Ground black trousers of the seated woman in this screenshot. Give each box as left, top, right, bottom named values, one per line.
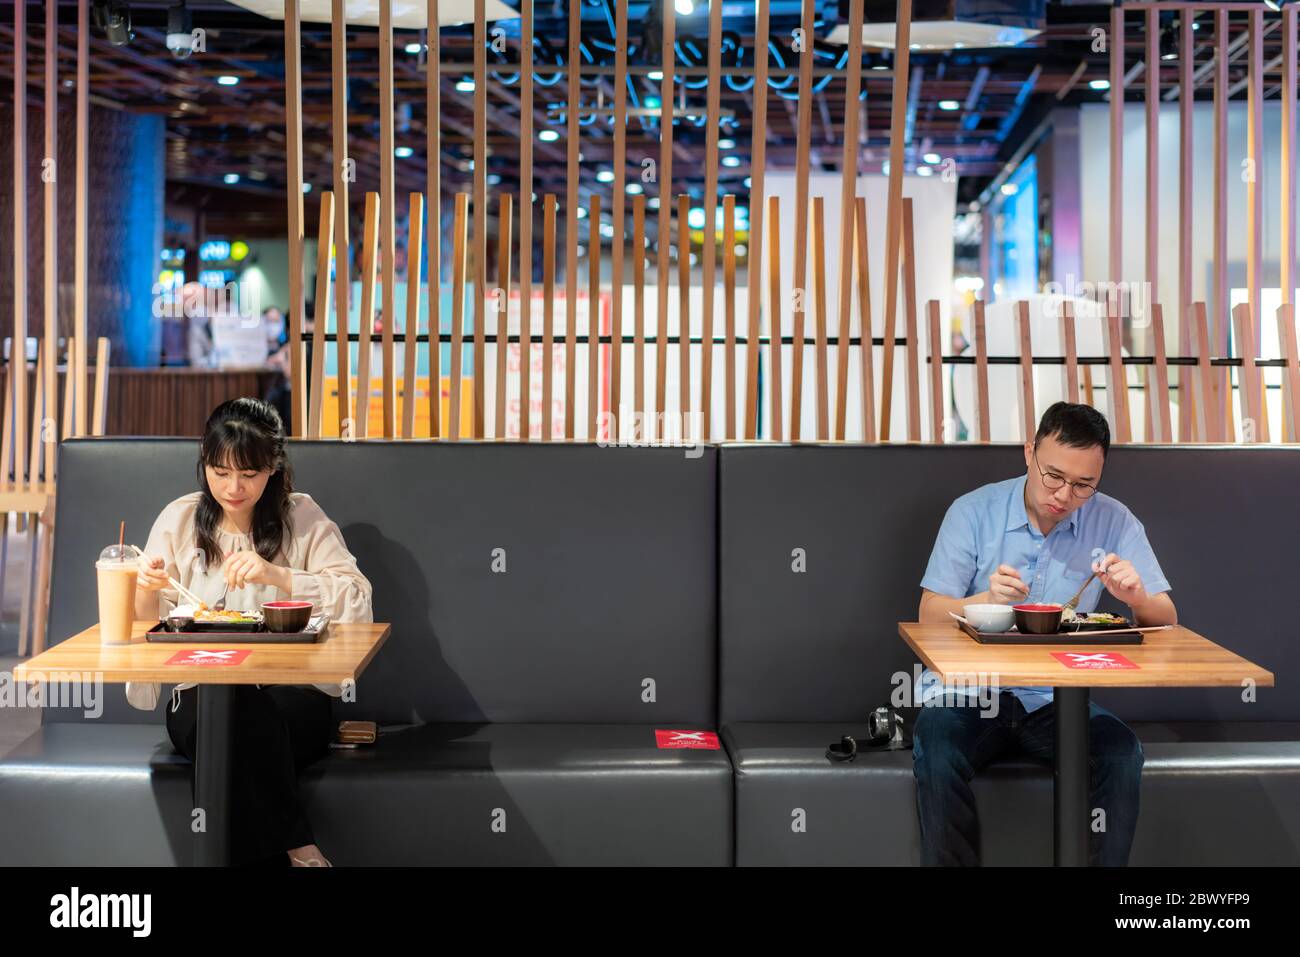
left=166, top=685, right=333, bottom=865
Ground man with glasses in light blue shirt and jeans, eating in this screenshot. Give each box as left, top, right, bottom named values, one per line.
left=913, top=402, right=1178, bottom=866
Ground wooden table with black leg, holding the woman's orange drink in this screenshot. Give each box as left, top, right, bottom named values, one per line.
left=13, top=622, right=393, bottom=865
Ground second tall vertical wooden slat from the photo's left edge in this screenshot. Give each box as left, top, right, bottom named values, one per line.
left=43, top=3, right=59, bottom=481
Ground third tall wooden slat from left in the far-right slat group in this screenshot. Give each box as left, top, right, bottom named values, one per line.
left=1170, top=9, right=1196, bottom=442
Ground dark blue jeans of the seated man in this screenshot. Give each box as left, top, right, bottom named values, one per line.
left=911, top=690, right=1143, bottom=867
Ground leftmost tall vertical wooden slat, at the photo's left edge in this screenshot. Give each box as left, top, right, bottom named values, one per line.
left=12, top=1, right=27, bottom=481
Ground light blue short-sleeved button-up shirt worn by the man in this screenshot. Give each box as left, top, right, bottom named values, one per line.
left=917, top=476, right=1169, bottom=711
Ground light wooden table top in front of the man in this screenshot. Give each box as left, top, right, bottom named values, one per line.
left=898, top=622, right=1273, bottom=688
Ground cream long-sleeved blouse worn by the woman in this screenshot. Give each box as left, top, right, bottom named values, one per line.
left=126, top=492, right=374, bottom=711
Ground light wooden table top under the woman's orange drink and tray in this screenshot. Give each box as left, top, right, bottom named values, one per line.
left=13, top=622, right=393, bottom=684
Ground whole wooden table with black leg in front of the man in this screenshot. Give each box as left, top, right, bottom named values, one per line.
left=898, top=622, right=1273, bottom=866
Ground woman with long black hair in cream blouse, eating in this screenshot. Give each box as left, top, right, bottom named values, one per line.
left=126, top=399, right=374, bottom=866
